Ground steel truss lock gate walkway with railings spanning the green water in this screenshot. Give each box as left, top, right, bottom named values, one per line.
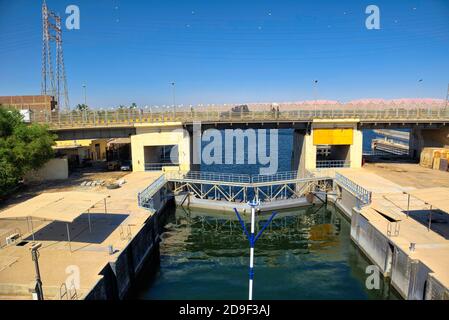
left=138, top=171, right=371, bottom=210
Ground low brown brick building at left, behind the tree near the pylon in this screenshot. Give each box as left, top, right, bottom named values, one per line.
left=0, top=95, right=57, bottom=112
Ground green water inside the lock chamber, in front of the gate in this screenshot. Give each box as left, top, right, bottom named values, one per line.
left=138, top=206, right=397, bottom=299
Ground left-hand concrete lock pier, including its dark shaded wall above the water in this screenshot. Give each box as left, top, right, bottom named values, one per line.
left=0, top=172, right=168, bottom=300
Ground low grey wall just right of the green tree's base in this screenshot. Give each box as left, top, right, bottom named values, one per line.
left=25, top=158, right=69, bottom=182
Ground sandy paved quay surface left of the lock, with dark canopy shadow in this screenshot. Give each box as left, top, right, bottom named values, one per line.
left=0, top=173, right=160, bottom=299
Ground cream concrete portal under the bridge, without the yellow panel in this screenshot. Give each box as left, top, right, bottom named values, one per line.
left=131, top=123, right=190, bottom=171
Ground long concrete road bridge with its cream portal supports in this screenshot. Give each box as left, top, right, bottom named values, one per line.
left=32, top=103, right=449, bottom=171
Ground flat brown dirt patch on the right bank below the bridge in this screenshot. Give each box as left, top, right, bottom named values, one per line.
left=363, top=162, right=449, bottom=189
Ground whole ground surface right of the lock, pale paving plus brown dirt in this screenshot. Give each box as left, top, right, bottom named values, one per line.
left=340, top=164, right=449, bottom=287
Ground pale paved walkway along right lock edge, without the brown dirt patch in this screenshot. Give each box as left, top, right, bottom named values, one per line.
left=339, top=165, right=449, bottom=288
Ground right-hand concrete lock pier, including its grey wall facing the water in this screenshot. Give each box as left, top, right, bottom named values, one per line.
left=330, top=169, right=449, bottom=300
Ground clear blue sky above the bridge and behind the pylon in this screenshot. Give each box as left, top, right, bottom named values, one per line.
left=0, top=0, right=449, bottom=107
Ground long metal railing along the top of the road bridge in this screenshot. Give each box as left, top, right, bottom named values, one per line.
left=26, top=104, right=449, bottom=129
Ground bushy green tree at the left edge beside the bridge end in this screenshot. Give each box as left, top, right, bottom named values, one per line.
left=0, top=108, right=56, bottom=196
